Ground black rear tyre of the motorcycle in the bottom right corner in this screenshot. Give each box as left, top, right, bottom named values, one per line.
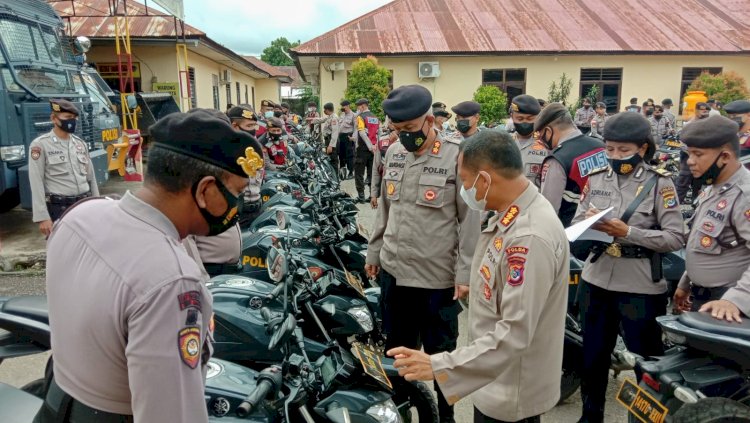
left=672, top=397, right=750, bottom=423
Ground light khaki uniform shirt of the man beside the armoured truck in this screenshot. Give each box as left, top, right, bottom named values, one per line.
left=29, top=131, right=99, bottom=222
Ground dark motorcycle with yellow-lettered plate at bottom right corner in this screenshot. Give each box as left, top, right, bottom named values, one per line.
left=617, top=312, right=750, bottom=423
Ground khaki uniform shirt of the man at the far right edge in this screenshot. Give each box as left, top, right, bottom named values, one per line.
left=678, top=167, right=750, bottom=316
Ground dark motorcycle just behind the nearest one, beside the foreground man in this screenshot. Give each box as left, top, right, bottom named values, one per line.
left=207, top=212, right=437, bottom=422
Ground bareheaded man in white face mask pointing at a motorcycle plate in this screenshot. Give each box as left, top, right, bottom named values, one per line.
left=388, top=131, right=569, bottom=422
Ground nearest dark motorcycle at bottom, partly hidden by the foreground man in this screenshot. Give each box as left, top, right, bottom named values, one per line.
left=0, top=294, right=402, bottom=423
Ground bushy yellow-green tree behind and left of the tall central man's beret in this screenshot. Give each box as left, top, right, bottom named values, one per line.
left=344, top=56, right=391, bottom=121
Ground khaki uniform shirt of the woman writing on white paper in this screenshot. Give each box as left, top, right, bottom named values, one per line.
left=573, top=163, right=685, bottom=294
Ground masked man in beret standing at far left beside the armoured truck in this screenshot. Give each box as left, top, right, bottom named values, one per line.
left=29, top=100, right=99, bottom=236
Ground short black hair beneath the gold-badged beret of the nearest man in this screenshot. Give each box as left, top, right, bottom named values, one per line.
left=144, top=144, right=228, bottom=194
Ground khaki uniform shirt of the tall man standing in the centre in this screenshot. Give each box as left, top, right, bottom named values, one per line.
left=367, top=137, right=479, bottom=289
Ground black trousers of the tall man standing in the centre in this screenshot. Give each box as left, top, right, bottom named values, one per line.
left=380, top=270, right=460, bottom=422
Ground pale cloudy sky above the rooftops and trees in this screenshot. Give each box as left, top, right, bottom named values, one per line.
left=151, top=0, right=392, bottom=56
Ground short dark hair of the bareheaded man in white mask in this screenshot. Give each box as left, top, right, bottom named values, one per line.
left=460, top=131, right=523, bottom=179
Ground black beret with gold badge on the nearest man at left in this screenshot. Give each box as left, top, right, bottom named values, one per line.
left=149, top=110, right=263, bottom=177
